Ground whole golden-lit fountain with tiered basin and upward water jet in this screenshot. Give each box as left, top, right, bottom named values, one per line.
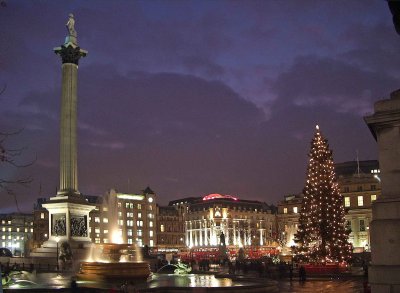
left=78, top=192, right=150, bottom=280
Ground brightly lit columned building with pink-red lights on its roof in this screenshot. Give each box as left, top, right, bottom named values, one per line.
left=172, top=194, right=276, bottom=251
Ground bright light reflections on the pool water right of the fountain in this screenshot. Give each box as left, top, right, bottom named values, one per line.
left=148, top=274, right=250, bottom=288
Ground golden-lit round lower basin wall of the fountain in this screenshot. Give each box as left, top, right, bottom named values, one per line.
left=77, top=262, right=150, bottom=281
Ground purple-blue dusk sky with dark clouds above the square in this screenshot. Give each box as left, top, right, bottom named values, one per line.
left=0, top=0, right=400, bottom=212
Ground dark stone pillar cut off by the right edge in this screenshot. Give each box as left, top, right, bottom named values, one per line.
left=364, top=90, right=400, bottom=293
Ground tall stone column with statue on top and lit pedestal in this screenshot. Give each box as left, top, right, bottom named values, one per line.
left=43, top=14, right=95, bottom=247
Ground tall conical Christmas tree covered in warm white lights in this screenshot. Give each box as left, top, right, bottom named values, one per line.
left=295, top=125, right=351, bottom=263
